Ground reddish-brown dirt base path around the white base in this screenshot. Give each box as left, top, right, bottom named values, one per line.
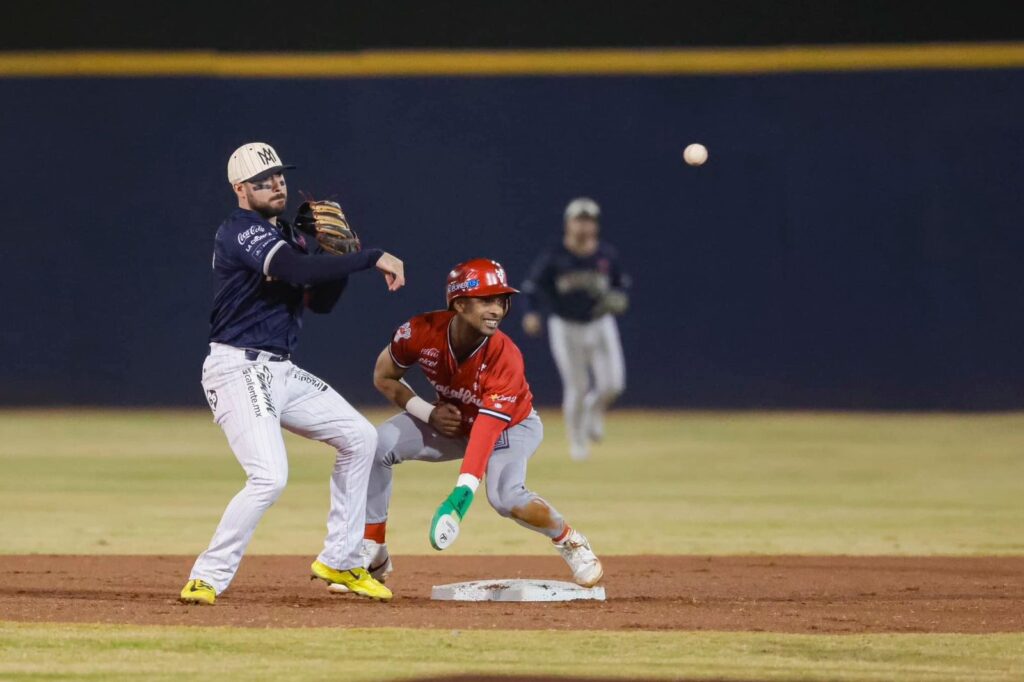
left=0, top=556, right=1024, bottom=633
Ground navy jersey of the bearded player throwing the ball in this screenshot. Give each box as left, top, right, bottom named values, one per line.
left=210, top=208, right=315, bottom=353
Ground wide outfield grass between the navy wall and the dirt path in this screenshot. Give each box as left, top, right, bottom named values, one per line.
left=0, top=411, right=1024, bottom=555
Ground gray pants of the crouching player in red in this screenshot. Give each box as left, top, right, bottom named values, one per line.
left=367, top=412, right=564, bottom=538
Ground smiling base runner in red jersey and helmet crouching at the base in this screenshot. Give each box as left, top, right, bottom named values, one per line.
left=362, top=258, right=604, bottom=587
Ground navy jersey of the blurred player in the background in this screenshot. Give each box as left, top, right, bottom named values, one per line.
left=521, top=242, right=630, bottom=322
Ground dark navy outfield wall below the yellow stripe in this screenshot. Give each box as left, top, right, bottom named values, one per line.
left=0, top=70, right=1024, bottom=409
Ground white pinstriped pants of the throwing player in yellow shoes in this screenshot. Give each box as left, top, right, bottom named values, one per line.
left=189, top=343, right=377, bottom=594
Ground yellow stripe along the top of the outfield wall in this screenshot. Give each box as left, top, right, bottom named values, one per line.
left=6, top=43, right=1024, bottom=78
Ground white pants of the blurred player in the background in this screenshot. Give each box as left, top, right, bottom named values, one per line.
left=548, top=314, right=626, bottom=459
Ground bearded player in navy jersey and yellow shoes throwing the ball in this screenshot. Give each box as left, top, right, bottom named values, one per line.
left=181, top=142, right=404, bottom=604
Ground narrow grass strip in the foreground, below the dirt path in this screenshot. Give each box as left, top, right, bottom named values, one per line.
left=0, top=623, right=1024, bottom=682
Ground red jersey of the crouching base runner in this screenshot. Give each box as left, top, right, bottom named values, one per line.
left=389, top=310, right=534, bottom=433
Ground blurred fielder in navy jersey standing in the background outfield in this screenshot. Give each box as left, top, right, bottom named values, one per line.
left=522, top=197, right=630, bottom=460
